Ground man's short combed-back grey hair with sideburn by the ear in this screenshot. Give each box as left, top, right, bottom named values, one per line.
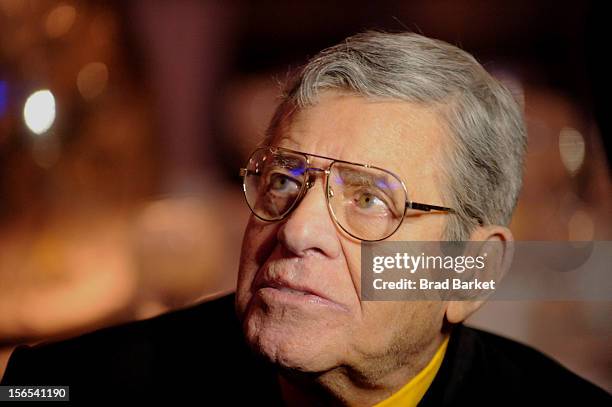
left=268, top=31, right=527, bottom=240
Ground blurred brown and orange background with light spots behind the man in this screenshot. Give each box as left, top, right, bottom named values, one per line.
left=0, top=0, right=612, bottom=391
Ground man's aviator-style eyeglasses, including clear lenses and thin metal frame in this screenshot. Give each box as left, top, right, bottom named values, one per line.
left=240, top=146, right=455, bottom=242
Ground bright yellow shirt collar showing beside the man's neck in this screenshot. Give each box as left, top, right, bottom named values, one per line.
left=374, top=336, right=448, bottom=407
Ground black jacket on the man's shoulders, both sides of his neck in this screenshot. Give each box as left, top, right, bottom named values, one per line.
left=1, top=295, right=612, bottom=406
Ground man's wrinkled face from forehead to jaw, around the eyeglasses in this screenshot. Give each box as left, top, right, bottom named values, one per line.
left=236, top=92, right=448, bottom=380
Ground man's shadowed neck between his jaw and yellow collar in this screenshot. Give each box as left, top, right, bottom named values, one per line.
left=278, top=336, right=445, bottom=407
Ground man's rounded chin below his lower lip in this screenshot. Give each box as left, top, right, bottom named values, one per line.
left=243, top=302, right=342, bottom=372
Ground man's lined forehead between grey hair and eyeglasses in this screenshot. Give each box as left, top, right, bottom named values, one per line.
left=269, top=92, right=447, bottom=182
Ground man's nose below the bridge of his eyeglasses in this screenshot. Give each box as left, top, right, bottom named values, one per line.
left=278, top=174, right=341, bottom=258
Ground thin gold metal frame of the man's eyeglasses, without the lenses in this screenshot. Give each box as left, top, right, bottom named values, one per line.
left=240, top=146, right=456, bottom=242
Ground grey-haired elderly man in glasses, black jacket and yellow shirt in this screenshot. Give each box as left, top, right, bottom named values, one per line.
left=4, top=32, right=610, bottom=406
